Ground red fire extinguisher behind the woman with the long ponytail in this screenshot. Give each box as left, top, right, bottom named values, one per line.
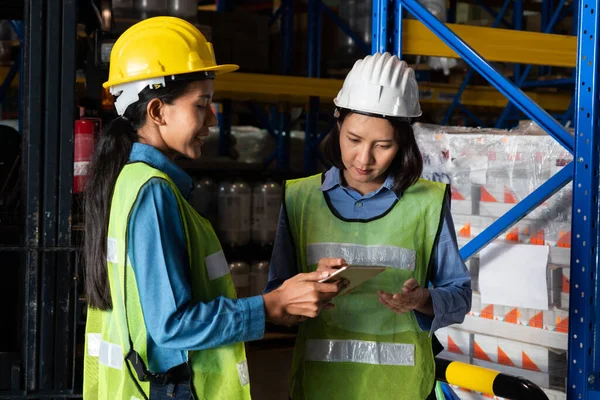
left=73, top=118, right=102, bottom=193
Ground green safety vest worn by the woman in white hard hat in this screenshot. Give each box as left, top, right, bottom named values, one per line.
left=285, top=175, right=447, bottom=400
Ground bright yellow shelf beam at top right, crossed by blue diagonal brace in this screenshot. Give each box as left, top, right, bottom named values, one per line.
left=402, top=19, right=577, bottom=68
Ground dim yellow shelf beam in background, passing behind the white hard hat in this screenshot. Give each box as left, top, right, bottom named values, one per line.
left=215, top=72, right=571, bottom=111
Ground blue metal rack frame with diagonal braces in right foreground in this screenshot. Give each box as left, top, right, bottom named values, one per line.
left=372, top=0, right=600, bottom=400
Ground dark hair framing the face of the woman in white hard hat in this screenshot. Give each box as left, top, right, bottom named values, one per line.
left=323, top=109, right=423, bottom=193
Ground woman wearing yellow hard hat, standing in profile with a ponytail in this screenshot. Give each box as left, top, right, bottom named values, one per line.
left=83, top=17, right=340, bottom=400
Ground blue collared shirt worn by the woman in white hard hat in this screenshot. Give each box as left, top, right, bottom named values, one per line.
left=265, top=167, right=471, bottom=332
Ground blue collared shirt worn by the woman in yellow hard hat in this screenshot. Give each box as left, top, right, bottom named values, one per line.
left=127, top=143, right=265, bottom=372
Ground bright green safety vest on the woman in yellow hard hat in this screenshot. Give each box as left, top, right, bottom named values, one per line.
left=83, top=162, right=250, bottom=400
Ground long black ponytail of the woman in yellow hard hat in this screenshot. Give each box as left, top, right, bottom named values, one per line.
left=83, top=80, right=192, bottom=310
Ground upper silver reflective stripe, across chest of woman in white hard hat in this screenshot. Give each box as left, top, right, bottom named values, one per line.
left=306, top=243, right=416, bottom=271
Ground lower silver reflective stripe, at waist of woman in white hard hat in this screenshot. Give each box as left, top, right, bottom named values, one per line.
left=304, top=339, right=415, bottom=367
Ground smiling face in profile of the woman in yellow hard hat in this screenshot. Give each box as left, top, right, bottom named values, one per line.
left=160, top=79, right=217, bottom=159
